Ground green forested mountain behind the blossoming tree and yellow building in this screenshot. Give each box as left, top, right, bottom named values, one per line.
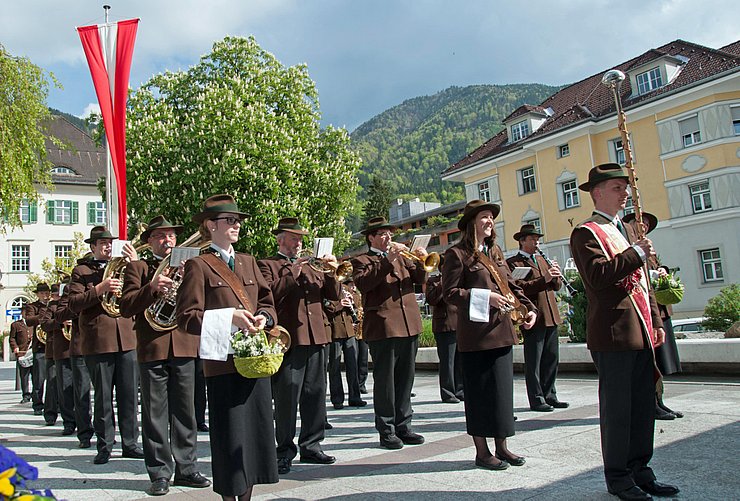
left=350, top=84, right=560, bottom=203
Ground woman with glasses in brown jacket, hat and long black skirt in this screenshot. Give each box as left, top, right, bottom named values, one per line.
left=177, top=195, right=278, bottom=500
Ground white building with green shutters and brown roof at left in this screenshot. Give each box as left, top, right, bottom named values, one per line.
left=0, top=117, right=106, bottom=331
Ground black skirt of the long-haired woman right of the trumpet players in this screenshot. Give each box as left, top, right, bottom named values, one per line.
left=460, top=346, right=514, bottom=438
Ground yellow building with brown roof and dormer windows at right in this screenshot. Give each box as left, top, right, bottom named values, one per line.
left=442, top=40, right=740, bottom=317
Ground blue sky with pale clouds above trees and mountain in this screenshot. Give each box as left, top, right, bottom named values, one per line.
left=0, top=0, right=740, bottom=132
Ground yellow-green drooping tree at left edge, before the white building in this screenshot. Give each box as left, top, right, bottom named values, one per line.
left=0, top=45, right=59, bottom=233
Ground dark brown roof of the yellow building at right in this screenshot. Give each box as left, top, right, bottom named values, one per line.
left=442, top=40, right=740, bottom=175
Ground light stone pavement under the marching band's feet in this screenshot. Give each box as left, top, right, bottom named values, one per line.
left=0, top=363, right=740, bottom=501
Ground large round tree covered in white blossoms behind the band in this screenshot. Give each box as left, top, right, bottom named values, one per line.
left=127, top=37, right=360, bottom=256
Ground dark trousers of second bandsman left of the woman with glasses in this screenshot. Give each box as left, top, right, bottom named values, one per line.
left=85, top=350, right=139, bottom=452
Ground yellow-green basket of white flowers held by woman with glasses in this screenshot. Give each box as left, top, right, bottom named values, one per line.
left=231, top=327, right=290, bottom=379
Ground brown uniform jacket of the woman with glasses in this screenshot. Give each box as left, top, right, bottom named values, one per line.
left=177, top=253, right=277, bottom=377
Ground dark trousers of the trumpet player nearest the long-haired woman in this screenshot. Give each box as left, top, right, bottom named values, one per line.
left=368, top=336, right=419, bottom=436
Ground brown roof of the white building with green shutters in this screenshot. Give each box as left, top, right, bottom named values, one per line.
left=46, top=115, right=106, bottom=185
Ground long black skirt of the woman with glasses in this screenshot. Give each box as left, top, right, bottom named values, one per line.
left=206, top=373, right=278, bottom=496
